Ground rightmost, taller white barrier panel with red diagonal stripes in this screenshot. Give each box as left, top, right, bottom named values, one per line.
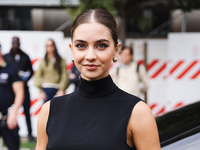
left=167, top=33, right=200, bottom=110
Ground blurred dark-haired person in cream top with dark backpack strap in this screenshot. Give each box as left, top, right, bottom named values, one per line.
left=113, top=46, right=148, bottom=97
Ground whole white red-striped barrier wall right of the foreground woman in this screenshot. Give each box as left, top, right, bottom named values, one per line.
left=127, top=33, right=200, bottom=116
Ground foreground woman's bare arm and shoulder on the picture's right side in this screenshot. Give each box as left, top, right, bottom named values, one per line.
left=128, top=102, right=161, bottom=150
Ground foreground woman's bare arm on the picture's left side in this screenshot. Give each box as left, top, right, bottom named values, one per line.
left=36, top=101, right=50, bottom=150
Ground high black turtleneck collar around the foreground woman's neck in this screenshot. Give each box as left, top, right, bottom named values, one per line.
left=78, top=75, right=117, bottom=97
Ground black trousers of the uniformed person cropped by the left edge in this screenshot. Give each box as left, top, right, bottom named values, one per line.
left=0, top=123, right=20, bottom=150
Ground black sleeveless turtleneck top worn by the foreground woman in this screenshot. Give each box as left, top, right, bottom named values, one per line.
left=46, top=76, right=140, bottom=150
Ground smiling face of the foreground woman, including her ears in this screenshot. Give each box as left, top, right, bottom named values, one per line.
left=69, top=23, right=121, bottom=80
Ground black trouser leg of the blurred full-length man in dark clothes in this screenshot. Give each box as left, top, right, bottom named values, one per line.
left=23, top=86, right=32, bottom=136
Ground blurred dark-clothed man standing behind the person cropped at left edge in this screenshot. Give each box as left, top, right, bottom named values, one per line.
left=5, top=37, right=35, bottom=141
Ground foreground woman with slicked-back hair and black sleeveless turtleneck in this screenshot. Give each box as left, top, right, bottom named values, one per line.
left=36, top=9, right=160, bottom=150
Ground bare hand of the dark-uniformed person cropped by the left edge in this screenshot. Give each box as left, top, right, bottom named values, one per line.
left=6, top=111, right=17, bottom=130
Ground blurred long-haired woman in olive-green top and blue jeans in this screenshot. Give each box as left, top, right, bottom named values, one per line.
left=34, top=39, right=68, bottom=102
